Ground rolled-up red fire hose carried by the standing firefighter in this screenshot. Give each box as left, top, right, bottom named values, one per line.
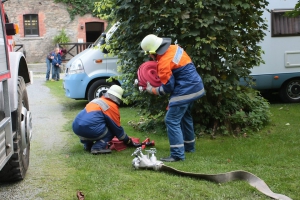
left=135, top=61, right=161, bottom=91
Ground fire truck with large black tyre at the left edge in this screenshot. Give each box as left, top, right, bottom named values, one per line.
left=0, top=0, right=32, bottom=182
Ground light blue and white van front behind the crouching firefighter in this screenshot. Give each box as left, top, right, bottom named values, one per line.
left=63, top=23, right=121, bottom=101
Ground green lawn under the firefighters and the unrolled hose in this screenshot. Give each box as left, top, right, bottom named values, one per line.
left=43, top=81, right=300, bottom=200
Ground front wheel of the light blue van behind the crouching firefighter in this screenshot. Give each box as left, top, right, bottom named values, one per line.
left=88, top=79, right=115, bottom=101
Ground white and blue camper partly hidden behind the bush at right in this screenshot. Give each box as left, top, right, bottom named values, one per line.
left=245, top=0, right=300, bottom=103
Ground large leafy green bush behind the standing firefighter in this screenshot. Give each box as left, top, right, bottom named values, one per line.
left=95, top=0, right=269, bottom=134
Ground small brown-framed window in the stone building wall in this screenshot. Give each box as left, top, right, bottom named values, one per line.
left=24, top=14, right=39, bottom=36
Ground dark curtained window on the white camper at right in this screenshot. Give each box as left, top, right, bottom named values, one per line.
left=271, top=10, right=300, bottom=37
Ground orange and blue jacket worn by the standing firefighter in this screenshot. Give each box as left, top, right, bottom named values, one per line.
left=157, top=45, right=205, bottom=107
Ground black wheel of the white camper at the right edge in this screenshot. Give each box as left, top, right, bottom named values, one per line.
left=280, top=79, right=300, bottom=103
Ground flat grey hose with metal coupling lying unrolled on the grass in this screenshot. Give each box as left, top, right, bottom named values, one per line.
left=132, top=147, right=291, bottom=200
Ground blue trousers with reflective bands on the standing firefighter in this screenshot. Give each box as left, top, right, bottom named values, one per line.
left=165, top=102, right=195, bottom=160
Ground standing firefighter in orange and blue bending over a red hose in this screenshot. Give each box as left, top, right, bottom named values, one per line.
left=141, top=34, right=205, bottom=162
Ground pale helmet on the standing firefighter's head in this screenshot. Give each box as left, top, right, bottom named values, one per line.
left=141, top=34, right=171, bottom=55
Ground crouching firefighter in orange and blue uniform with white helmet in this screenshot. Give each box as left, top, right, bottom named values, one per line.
left=72, top=85, right=138, bottom=154
